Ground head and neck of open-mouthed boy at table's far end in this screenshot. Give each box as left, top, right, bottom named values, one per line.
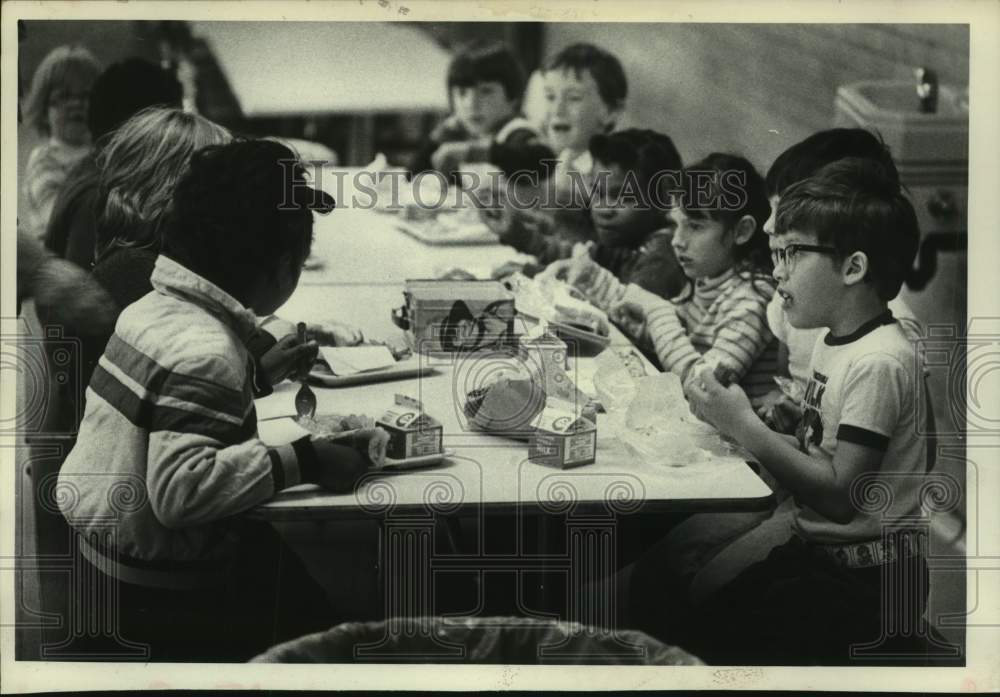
left=542, top=43, right=628, bottom=190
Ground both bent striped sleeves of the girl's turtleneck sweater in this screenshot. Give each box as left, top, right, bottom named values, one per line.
left=646, top=284, right=772, bottom=382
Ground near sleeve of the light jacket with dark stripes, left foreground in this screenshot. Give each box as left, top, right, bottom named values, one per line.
left=146, top=355, right=318, bottom=528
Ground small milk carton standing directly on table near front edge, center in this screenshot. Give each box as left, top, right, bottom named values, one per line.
left=528, top=403, right=597, bottom=469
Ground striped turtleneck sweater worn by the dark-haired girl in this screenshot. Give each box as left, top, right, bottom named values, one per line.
left=580, top=269, right=778, bottom=397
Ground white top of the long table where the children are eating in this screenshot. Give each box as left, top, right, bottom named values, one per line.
left=250, top=187, right=772, bottom=520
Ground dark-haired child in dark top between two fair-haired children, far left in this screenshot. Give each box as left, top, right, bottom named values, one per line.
left=45, top=58, right=183, bottom=269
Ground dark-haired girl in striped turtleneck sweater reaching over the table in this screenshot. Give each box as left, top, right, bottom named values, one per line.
left=567, top=153, right=777, bottom=398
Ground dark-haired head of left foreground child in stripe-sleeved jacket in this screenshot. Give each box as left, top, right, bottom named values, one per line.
left=163, top=140, right=334, bottom=303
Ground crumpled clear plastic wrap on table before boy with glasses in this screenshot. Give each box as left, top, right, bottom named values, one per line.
left=594, top=350, right=728, bottom=467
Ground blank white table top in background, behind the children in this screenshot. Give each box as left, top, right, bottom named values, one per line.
left=192, top=22, right=451, bottom=117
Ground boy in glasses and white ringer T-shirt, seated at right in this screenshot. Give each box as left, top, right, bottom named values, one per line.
left=685, top=158, right=928, bottom=665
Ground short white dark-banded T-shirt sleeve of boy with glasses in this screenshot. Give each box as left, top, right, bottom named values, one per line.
left=837, top=354, right=915, bottom=451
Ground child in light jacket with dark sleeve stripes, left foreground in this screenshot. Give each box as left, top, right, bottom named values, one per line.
left=59, top=141, right=370, bottom=660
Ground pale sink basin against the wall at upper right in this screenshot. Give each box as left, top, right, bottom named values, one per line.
left=834, top=80, right=969, bottom=164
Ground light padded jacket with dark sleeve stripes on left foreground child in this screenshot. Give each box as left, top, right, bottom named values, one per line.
left=59, top=256, right=317, bottom=580
